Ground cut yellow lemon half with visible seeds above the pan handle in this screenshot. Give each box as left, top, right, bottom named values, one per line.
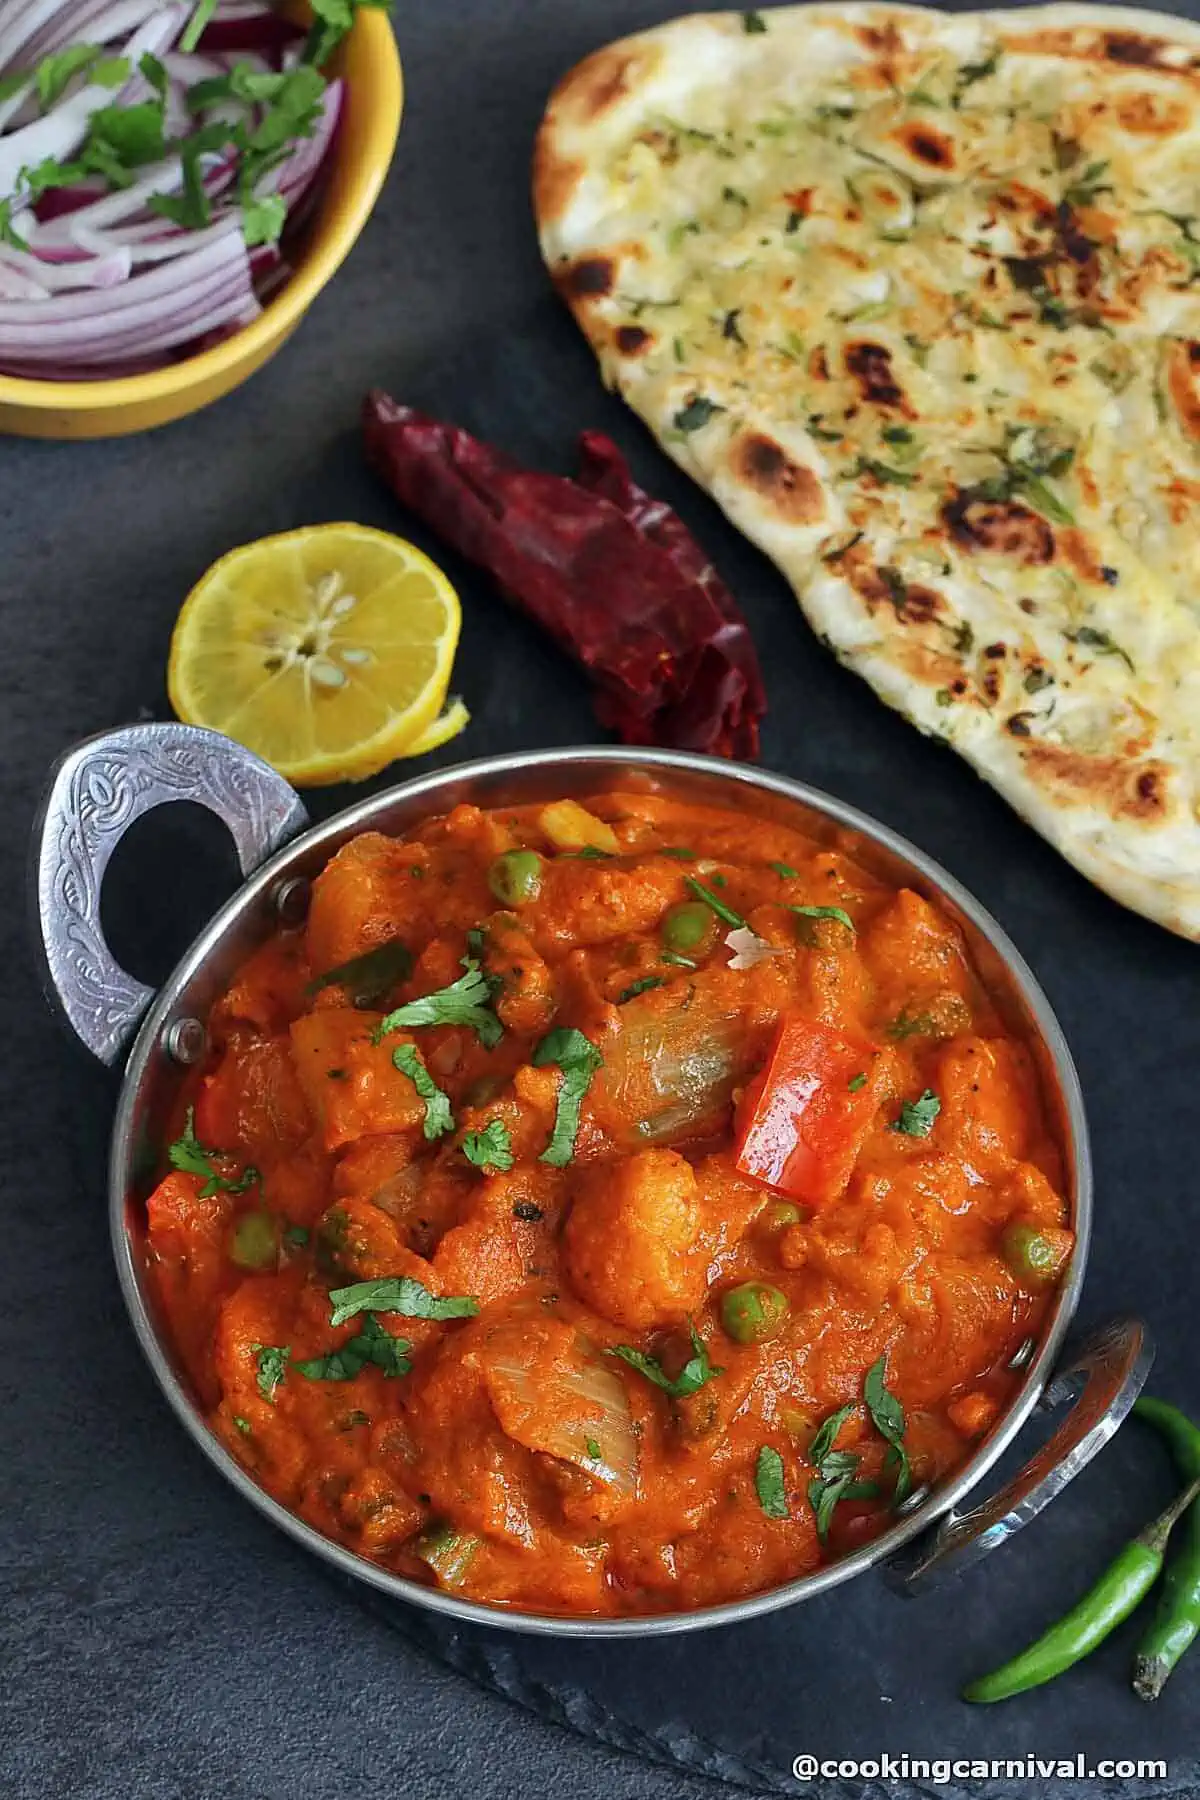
left=167, top=526, right=466, bottom=787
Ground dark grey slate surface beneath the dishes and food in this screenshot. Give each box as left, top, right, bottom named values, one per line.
left=0, top=0, right=1200, bottom=1800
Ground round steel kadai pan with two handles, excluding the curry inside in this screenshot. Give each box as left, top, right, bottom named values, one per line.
left=34, top=724, right=1153, bottom=1638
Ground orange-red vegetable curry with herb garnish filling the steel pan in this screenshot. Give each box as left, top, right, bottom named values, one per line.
left=148, top=792, right=1070, bottom=1615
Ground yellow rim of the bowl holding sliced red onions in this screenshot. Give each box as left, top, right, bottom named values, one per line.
left=0, top=7, right=405, bottom=412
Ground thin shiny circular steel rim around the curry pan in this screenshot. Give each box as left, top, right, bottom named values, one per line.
left=108, top=745, right=1092, bottom=1640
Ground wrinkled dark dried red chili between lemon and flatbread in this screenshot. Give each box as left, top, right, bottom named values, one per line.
left=363, top=392, right=766, bottom=758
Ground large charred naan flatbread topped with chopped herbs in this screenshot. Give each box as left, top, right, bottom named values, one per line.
left=534, top=5, right=1200, bottom=938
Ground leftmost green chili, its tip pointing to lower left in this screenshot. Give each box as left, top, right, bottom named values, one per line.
left=963, top=1476, right=1200, bottom=1705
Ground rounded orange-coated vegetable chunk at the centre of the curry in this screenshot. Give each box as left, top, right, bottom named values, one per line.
left=563, top=1150, right=707, bottom=1330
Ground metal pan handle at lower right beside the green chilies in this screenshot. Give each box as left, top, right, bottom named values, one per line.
left=885, top=1319, right=1155, bottom=1595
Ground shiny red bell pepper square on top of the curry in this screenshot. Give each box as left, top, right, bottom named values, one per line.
left=738, top=1017, right=880, bottom=1206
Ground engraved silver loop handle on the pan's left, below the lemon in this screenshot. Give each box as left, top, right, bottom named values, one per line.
left=34, top=724, right=308, bottom=1064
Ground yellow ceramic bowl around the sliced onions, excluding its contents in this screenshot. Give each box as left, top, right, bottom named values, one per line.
left=0, top=7, right=403, bottom=437
